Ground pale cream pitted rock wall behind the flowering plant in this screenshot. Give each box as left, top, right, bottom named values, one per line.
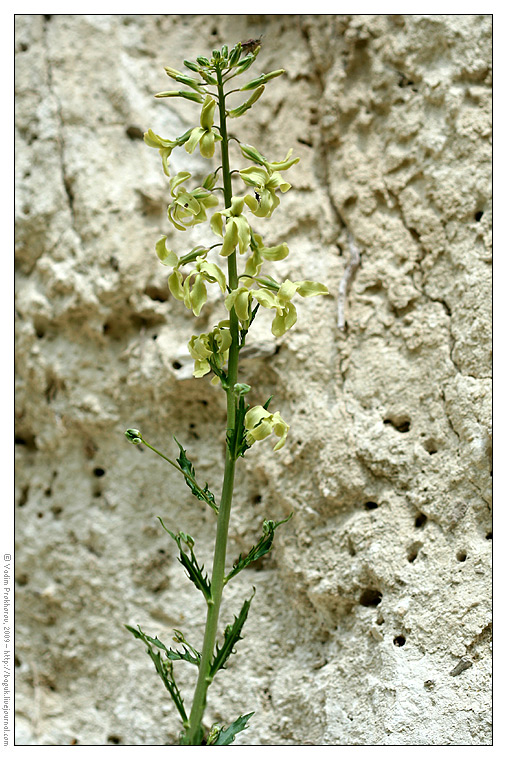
left=16, top=14, right=492, bottom=745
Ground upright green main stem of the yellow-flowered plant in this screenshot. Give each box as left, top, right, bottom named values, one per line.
left=185, top=66, right=240, bottom=745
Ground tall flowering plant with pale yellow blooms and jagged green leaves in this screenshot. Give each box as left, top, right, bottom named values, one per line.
left=126, top=40, right=328, bottom=745
